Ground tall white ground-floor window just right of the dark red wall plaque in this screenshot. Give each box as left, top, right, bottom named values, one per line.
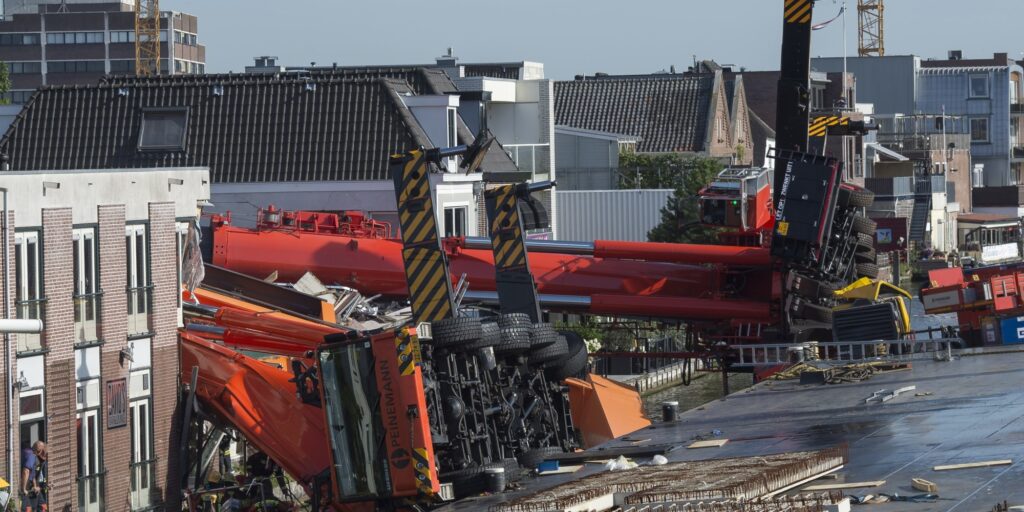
left=128, top=369, right=156, bottom=510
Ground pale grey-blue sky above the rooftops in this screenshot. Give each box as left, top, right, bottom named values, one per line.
left=172, top=0, right=1024, bottom=79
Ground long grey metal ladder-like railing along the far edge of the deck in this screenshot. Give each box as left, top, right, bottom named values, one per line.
left=730, top=338, right=964, bottom=368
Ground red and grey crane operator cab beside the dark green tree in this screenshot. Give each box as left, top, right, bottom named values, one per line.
left=698, top=168, right=772, bottom=231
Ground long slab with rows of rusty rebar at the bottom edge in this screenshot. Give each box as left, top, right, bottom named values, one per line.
left=490, top=446, right=847, bottom=512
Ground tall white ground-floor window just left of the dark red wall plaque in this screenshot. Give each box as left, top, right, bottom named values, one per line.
left=75, top=379, right=103, bottom=512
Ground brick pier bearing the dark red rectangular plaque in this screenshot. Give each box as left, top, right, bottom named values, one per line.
left=96, top=205, right=131, bottom=511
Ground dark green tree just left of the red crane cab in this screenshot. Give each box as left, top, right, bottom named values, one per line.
left=647, top=157, right=723, bottom=244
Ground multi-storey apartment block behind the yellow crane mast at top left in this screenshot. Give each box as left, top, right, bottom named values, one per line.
left=0, top=0, right=206, bottom=104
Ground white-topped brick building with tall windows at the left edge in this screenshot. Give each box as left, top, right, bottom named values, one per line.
left=0, top=168, right=210, bottom=511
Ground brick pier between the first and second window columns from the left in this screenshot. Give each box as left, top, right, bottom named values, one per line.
left=42, top=208, right=78, bottom=510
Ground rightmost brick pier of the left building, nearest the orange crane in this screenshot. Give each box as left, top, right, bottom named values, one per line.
left=150, top=203, right=181, bottom=510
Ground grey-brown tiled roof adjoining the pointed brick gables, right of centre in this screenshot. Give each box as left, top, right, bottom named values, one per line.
left=555, top=75, right=715, bottom=153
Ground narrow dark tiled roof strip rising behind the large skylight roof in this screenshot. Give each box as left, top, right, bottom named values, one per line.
left=100, top=66, right=458, bottom=94
